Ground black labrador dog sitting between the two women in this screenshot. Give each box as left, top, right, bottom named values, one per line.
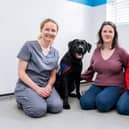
left=55, top=39, right=91, bottom=109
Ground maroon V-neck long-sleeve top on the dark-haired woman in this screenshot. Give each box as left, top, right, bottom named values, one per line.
left=81, top=47, right=128, bottom=87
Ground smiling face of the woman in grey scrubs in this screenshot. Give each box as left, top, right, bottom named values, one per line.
left=40, top=21, right=58, bottom=43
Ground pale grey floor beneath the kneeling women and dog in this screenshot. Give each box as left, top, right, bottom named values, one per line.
left=0, top=87, right=129, bottom=129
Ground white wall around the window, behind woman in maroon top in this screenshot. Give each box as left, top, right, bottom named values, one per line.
left=83, top=4, right=129, bottom=70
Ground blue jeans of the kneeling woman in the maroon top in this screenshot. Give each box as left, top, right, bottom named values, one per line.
left=80, top=85, right=122, bottom=112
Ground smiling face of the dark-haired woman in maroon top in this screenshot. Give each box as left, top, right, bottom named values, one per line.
left=101, top=25, right=115, bottom=44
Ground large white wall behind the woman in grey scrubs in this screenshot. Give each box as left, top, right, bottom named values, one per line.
left=0, top=0, right=91, bottom=94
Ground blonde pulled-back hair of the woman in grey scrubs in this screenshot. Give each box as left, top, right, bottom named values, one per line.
left=38, top=18, right=59, bottom=39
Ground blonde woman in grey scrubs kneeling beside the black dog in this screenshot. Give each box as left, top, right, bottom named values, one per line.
left=15, top=19, right=63, bottom=117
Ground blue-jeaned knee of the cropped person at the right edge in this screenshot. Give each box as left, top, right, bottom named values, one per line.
left=116, top=91, right=129, bottom=115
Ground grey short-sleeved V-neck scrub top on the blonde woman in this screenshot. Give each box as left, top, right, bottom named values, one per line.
left=17, top=40, right=59, bottom=87
